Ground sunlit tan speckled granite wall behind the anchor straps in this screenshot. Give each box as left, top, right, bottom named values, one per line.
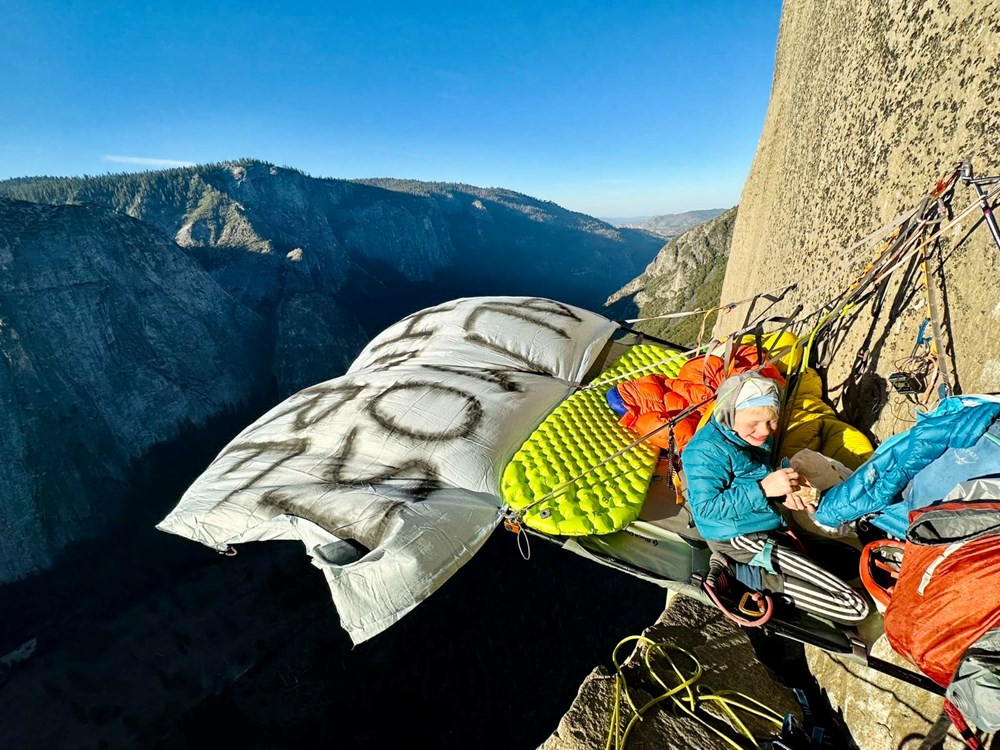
left=719, top=0, right=1000, bottom=436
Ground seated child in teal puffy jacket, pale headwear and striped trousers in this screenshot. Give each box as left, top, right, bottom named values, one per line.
left=682, top=372, right=868, bottom=623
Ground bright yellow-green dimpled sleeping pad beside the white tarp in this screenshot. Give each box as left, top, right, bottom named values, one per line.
left=500, top=345, right=686, bottom=536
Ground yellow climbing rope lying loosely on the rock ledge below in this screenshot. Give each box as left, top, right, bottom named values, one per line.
left=604, top=635, right=782, bottom=750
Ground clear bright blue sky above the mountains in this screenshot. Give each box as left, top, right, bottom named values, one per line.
left=0, top=0, right=780, bottom=216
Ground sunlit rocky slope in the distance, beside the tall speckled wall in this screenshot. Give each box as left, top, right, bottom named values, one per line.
left=606, top=207, right=736, bottom=345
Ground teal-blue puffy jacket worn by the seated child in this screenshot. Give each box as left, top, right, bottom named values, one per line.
left=682, top=419, right=783, bottom=540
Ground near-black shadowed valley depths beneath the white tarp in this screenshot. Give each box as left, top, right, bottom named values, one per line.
left=0, top=384, right=664, bottom=749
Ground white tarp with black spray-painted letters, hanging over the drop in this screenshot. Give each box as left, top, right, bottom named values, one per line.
left=157, top=297, right=616, bottom=643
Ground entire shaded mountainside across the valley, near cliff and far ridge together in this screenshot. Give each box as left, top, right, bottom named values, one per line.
left=0, top=160, right=662, bottom=583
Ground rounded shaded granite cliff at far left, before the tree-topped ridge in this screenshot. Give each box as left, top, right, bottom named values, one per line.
left=0, top=198, right=270, bottom=582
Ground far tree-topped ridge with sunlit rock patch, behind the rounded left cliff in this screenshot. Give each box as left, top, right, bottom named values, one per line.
left=0, top=160, right=661, bottom=334
